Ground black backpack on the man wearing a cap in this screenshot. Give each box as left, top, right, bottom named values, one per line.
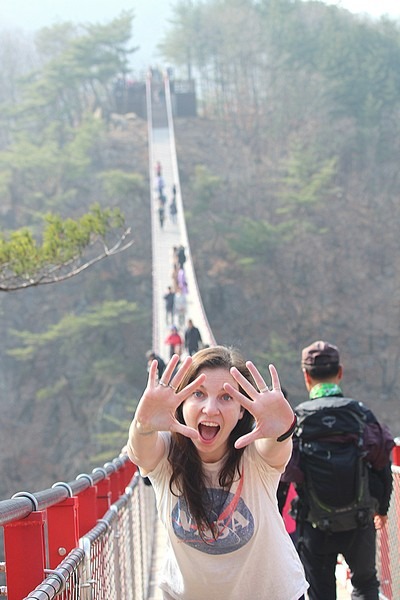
left=296, top=397, right=375, bottom=532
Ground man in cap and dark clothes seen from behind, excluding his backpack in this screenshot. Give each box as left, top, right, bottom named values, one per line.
left=282, top=340, right=393, bottom=600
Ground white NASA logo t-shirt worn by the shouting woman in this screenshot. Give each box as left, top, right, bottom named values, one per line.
left=148, top=433, right=308, bottom=600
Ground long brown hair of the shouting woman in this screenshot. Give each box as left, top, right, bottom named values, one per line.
left=168, top=346, right=255, bottom=541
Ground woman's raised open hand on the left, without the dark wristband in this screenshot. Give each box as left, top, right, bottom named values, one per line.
left=134, top=354, right=205, bottom=439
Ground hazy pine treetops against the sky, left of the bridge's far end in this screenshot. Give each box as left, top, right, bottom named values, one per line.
left=16, top=11, right=135, bottom=126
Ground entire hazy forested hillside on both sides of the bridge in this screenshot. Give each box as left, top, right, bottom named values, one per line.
left=0, top=0, right=400, bottom=498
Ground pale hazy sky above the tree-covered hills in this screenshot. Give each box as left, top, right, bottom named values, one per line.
left=0, top=0, right=400, bottom=71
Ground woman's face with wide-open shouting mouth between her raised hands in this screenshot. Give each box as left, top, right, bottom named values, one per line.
left=182, top=367, right=243, bottom=463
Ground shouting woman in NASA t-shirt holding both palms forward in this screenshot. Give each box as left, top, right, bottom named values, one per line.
left=128, top=346, right=307, bottom=600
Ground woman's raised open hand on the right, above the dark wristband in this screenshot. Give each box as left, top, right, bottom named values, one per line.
left=224, top=361, right=293, bottom=448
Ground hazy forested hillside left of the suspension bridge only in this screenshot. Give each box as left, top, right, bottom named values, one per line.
left=0, top=15, right=152, bottom=498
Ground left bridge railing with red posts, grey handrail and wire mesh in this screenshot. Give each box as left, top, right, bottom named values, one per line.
left=0, top=455, right=156, bottom=600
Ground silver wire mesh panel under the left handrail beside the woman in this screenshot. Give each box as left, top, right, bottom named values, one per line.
left=25, top=476, right=156, bottom=600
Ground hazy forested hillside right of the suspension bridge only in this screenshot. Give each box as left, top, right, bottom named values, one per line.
left=162, top=0, right=400, bottom=434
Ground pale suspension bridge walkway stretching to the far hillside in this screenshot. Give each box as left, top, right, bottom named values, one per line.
left=146, top=80, right=216, bottom=600
